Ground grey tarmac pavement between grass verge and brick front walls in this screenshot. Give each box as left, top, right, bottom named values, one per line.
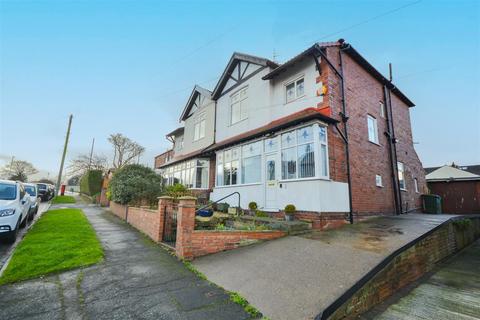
left=0, top=205, right=249, bottom=320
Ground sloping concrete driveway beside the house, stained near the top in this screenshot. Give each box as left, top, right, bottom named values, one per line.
left=194, top=214, right=452, bottom=320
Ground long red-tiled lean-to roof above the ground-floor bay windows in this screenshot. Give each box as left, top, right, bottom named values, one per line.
left=160, top=108, right=339, bottom=168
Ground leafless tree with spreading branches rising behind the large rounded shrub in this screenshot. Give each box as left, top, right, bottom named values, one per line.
left=108, top=133, right=145, bottom=169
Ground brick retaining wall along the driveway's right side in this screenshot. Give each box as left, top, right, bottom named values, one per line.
left=321, top=217, right=480, bottom=320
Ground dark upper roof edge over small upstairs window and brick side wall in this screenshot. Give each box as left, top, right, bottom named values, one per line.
left=262, top=40, right=415, bottom=107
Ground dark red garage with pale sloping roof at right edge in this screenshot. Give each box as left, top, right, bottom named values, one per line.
left=425, top=163, right=480, bottom=214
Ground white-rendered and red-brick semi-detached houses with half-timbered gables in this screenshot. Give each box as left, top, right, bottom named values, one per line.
left=155, top=40, right=426, bottom=227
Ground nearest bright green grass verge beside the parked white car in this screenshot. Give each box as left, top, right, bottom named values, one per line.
left=0, top=209, right=103, bottom=285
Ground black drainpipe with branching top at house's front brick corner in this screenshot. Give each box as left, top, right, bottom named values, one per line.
left=315, top=40, right=353, bottom=224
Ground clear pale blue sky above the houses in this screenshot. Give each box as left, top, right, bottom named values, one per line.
left=0, top=0, right=480, bottom=180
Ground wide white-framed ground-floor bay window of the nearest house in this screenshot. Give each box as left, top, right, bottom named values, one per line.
left=216, top=124, right=329, bottom=186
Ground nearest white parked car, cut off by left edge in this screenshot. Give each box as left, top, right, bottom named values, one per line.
left=0, top=180, right=32, bottom=242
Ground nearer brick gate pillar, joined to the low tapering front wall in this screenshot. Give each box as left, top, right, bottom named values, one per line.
left=175, top=197, right=197, bottom=260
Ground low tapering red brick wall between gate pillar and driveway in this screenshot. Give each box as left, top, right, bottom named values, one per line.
left=191, top=230, right=286, bottom=257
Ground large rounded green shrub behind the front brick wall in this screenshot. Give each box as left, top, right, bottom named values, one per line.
left=108, top=164, right=162, bottom=206
